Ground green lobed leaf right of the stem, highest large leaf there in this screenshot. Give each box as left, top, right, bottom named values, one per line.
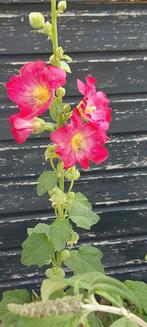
left=69, top=193, right=100, bottom=229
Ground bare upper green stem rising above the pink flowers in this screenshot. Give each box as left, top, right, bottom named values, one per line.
left=51, top=0, right=60, bottom=67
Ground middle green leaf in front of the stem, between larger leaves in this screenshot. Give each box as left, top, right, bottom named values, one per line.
left=50, top=219, right=72, bottom=251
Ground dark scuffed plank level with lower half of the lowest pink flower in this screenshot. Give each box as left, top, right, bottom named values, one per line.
left=0, top=134, right=147, bottom=180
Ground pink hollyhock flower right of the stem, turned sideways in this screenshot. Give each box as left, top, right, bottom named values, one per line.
left=77, top=76, right=112, bottom=131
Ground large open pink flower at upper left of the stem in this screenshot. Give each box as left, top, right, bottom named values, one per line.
left=6, top=60, right=66, bottom=117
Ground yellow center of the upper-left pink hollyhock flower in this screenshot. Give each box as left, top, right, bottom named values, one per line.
left=33, top=85, right=51, bottom=106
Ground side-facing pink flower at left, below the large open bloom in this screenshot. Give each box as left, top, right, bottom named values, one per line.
left=9, top=113, right=45, bottom=144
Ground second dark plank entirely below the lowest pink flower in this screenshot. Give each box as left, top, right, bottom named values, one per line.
left=0, top=203, right=147, bottom=251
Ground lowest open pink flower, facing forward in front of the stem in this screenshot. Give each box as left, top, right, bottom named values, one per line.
left=50, top=109, right=108, bottom=169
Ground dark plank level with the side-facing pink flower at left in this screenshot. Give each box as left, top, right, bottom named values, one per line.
left=0, top=94, right=147, bottom=142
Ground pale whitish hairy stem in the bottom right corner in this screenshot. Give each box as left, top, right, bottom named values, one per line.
left=82, top=297, right=147, bottom=327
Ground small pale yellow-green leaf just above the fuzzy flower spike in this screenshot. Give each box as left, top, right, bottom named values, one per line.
left=41, top=279, right=67, bottom=301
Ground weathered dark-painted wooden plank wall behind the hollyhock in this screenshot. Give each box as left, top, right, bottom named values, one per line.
left=0, top=0, right=147, bottom=291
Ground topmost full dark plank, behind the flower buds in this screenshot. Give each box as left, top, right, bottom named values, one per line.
left=0, top=2, right=147, bottom=54
